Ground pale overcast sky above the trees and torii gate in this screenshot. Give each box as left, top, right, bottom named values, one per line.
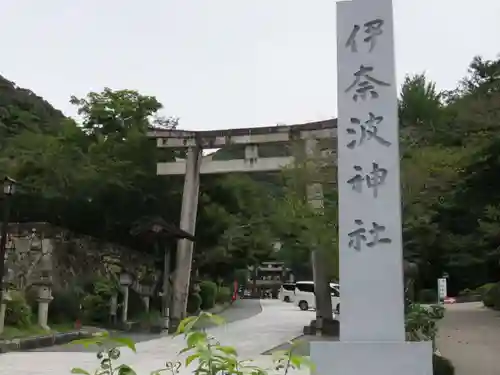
left=0, top=0, right=500, bottom=129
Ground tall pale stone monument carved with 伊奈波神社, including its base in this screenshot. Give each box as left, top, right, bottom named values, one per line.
left=311, top=0, right=432, bottom=375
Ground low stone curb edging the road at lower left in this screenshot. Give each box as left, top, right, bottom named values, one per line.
left=0, top=330, right=100, bottom=353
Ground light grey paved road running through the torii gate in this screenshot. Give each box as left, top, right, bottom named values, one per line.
left=0, top=300, right=314, bottom=375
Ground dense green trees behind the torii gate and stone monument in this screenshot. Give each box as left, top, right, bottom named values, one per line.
left=0, top=53, right=500, bottom=294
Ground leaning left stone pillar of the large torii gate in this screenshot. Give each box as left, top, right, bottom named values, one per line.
left=170, top=147, right=202, bottom=329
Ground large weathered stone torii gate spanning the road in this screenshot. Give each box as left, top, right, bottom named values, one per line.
left=148, top=119, right=337, bottom=327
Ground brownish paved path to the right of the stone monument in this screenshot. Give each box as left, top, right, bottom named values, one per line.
left=438, top=303, right=500, bottom=375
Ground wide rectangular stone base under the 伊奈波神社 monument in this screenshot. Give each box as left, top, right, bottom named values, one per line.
left=311, top=341, right=433, bottom=375
